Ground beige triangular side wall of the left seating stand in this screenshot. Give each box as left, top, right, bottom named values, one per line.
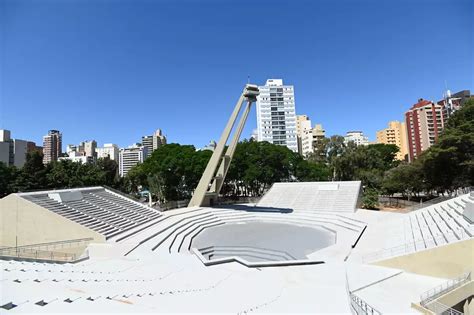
left=0, top=194, right=105, bottom=247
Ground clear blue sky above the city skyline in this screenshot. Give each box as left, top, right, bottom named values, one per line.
left=0, top=0, right=473, bottom=147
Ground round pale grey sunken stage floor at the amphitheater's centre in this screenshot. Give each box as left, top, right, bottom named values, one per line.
left=193, top=222, right=336, bottom=262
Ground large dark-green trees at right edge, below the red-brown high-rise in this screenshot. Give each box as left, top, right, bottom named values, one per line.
left=383, top=99, right=474, bottom=196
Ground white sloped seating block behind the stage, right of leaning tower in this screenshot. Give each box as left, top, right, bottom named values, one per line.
left=258, top=181, right=361, bottom=212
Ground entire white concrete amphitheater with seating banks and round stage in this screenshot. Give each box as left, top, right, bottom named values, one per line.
left=0, top=182, right=474, bottom=314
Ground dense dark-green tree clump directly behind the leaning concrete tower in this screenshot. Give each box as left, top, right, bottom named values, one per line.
left=124, top=140, right=329, bottom=202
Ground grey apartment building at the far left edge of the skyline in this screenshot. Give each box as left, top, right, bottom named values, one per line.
left=0, top=129, right=34, bottom=167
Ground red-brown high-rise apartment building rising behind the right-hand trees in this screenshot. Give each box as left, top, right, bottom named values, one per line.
left=405, top=98, right=446, bottom=162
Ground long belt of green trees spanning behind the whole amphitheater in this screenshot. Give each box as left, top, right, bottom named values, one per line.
left=0, top=100, right=474, bottom=208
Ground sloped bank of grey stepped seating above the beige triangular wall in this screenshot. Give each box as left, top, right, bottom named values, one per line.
left=21, top=188, right=161, bottom=239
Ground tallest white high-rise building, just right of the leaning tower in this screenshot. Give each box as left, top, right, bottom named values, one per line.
left=257, top=79, right=298, bottom=152
